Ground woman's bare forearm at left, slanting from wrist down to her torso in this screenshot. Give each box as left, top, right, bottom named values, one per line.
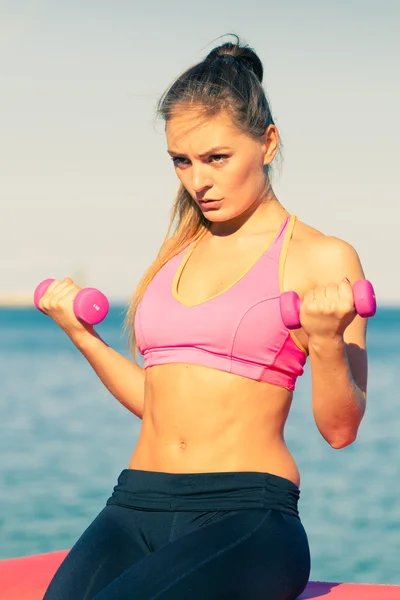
left=72, top=331, right=144, bottom=419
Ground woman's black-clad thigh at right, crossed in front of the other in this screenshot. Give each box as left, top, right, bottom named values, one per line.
left=95, top=510, right=310, bottom=600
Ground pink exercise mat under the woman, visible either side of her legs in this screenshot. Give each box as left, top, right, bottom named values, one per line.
left=0, top=550, right=400, bottom=600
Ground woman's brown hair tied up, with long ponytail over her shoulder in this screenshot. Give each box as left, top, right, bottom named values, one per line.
left=124, top=36, right=274, bottom=359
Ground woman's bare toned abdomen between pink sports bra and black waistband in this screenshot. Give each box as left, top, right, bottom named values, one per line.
left=129, top=364, right=299, bottom=485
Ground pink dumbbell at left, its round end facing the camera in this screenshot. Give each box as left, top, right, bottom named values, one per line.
left=33, top=279, right=109, bottom=325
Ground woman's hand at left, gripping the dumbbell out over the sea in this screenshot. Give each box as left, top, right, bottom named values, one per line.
left=39, top=277, right=94, bottom=342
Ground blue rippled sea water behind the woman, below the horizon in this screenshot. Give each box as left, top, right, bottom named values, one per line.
left=0, top=306, right=400, bottom=584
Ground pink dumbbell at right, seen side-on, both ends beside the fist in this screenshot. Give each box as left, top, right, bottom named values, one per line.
left=280, top=279, right=376, bottom=329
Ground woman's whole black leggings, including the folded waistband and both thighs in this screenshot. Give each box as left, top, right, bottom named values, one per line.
left=44, top=469, right=310, bottom=600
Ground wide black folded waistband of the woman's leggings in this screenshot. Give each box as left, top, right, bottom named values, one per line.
left=107, top=469, right=300, bottom=517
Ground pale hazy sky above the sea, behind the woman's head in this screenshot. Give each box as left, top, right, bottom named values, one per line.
left=0, top=0, right=400, bottom=305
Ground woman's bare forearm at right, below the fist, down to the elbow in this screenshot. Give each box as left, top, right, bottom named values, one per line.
left=309, top=338, right=365, bottom=448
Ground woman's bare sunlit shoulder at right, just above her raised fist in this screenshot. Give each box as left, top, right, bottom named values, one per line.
left=292, top=220, right=363, bottom=285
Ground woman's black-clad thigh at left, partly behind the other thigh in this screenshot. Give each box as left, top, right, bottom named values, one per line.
left=43, top=506, right=156, bottom=600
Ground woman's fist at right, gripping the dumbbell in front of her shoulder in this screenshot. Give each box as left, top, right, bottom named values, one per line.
left=300, top=278, right=357, bottom=339
